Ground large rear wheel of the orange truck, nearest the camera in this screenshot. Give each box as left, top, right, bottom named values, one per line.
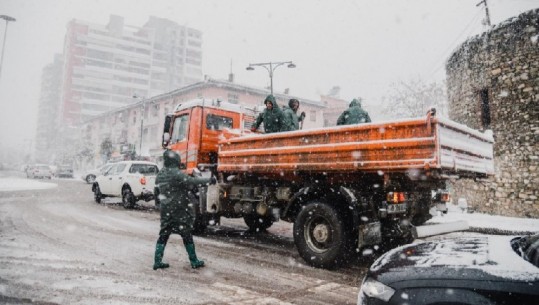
left=294, top=201, right=352, bottom=268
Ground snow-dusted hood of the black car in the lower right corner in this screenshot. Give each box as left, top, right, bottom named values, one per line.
left=369, top=235, right=539, bottom=285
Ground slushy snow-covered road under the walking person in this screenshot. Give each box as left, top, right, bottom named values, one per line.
left=0, top=175, right=370, bottom=305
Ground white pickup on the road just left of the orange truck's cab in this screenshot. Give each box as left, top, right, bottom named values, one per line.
left=92, top=161, right=159, bottom=209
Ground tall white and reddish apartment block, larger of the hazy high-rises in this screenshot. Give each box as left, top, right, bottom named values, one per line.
left=60, top=15, right=202, bottom=126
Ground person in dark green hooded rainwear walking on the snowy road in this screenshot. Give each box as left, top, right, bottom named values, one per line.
left=153, top=150, right=215, bottom=270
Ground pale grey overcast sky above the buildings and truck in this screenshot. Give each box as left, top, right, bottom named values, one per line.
left=0, top=0, right=539, bottom=147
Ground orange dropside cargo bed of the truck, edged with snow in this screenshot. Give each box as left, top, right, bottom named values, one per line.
left=218, top=117, right=494, bottom=176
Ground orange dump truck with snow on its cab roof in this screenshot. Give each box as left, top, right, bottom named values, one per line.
left=163, top=99, right=494, bottom=268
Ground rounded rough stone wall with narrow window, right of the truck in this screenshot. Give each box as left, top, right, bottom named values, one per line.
left=446, top=9, right=539, bottom=218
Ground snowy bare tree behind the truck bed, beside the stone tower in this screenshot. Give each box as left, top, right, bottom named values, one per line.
left=382, top=77, right=447, bottom=119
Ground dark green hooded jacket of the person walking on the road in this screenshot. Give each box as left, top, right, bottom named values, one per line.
left=155, top=150, right=210, bottom=235
